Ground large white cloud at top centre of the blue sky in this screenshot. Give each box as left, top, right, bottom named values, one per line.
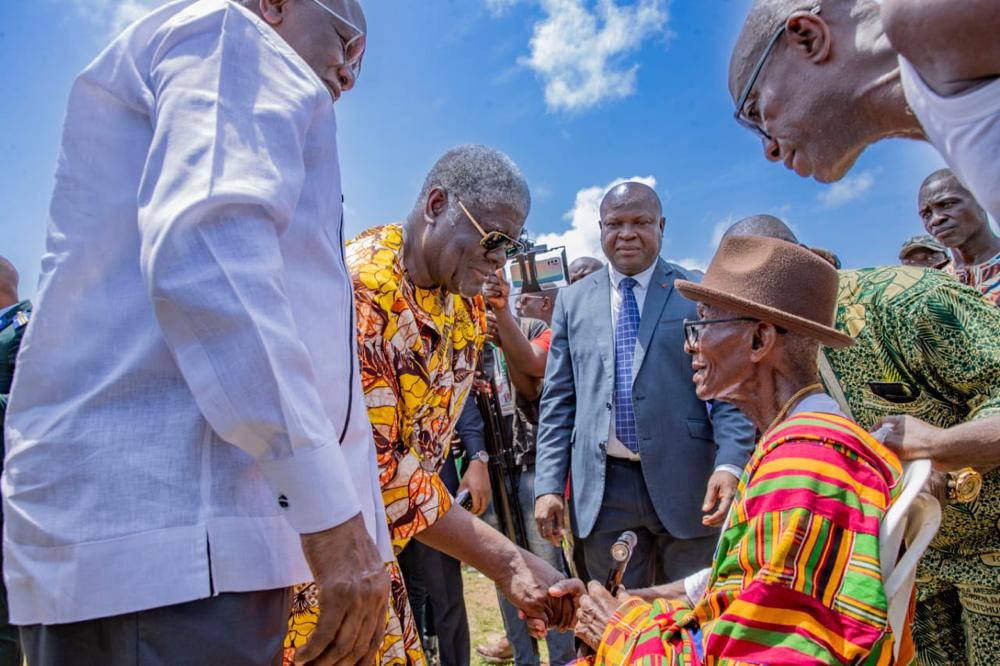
left=516, top=0, right=669, bottom=111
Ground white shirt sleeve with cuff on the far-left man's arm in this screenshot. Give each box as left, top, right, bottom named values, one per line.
left=138, top=16, right=361, bottom=533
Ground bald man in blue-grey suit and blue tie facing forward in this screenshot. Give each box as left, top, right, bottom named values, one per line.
left=535, top=182, right=754, bottom=587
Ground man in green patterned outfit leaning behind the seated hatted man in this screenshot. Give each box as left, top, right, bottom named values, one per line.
left=726, top=215, right=1000, bottom=666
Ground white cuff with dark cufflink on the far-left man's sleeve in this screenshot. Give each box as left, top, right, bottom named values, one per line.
left=259, top=444, right=361, bottom=534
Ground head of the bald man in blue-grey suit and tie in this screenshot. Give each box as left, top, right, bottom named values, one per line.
left=601, top=182, right=665, bottom=275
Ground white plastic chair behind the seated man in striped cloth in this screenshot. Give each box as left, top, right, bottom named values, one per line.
left=878, top=460, right=941, bottom=657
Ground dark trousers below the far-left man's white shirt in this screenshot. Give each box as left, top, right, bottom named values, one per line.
left=21, top=589, right=291, bottom=666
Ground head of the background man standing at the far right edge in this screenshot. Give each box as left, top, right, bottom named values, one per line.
left=917, top=170, right=1000, bottom=268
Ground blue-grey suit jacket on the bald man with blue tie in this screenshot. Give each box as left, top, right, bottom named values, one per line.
left=535, top=259, right=755, bottom=539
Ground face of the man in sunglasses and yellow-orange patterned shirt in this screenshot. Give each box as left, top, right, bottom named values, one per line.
left=403, top=187, right=524, bottom=298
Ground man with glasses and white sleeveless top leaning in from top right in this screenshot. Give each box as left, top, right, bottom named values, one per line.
left=729, top=0, right=1000, bottom=223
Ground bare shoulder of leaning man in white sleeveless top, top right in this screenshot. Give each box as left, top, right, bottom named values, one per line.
left=882, top=0, right=1000, bottom=97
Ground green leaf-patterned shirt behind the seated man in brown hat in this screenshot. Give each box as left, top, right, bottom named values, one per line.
left=826, top=266, right=1000, bottom=555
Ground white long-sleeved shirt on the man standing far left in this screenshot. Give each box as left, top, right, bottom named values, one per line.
left=3, top=0, right=391, bottom=624
